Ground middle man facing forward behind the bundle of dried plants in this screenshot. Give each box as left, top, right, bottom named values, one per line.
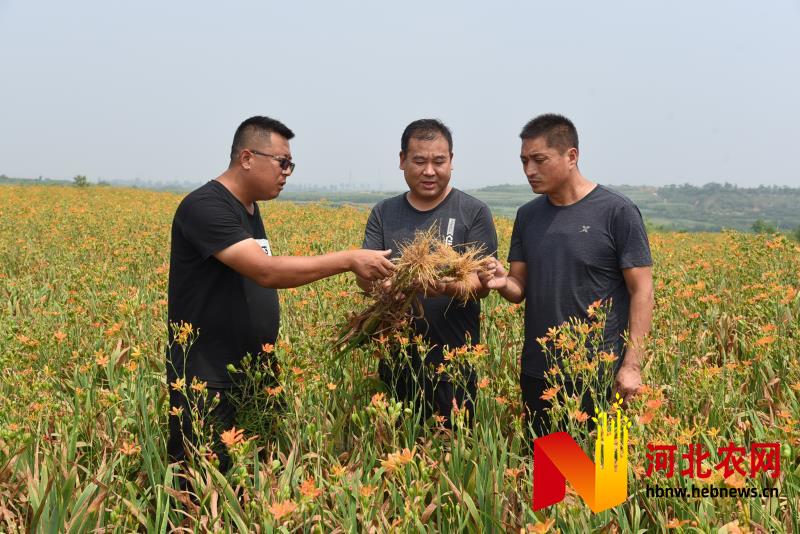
left=358, top=119, right=497, bottom=427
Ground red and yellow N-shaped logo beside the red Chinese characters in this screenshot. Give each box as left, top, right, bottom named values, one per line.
left=532, top=395, right=631, bottom=513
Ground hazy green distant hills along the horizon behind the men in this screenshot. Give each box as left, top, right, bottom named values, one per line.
left=0, top=175, right=800, bottom=232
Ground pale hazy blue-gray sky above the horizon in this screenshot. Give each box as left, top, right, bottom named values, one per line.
left=0, top=0, right=800, bottom=189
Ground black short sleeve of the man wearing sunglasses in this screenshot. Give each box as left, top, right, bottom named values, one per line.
left=175, top=198, right=253, bottom=259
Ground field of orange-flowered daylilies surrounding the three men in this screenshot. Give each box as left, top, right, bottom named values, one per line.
left=0, top=186, right=800, bottom=533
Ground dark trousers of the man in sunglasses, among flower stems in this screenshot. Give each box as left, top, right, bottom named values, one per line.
left=167, top=387, right=237, bottom=473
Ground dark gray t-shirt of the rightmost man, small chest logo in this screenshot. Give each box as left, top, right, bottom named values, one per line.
left=508, top=185, right=653, bottom=378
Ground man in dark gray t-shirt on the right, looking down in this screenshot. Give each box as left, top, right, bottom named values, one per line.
left=481, top=114, right=653, bottom=435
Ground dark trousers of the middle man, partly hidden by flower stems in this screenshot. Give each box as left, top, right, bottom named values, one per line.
left=378, top=355, right=477, bottom=428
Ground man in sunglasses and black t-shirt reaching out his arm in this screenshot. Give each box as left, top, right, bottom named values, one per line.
left=167, top=116, right=394, bottom=469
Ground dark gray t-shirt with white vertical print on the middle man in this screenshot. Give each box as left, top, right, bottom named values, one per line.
left=363, top=188, right=497, bottom=365
